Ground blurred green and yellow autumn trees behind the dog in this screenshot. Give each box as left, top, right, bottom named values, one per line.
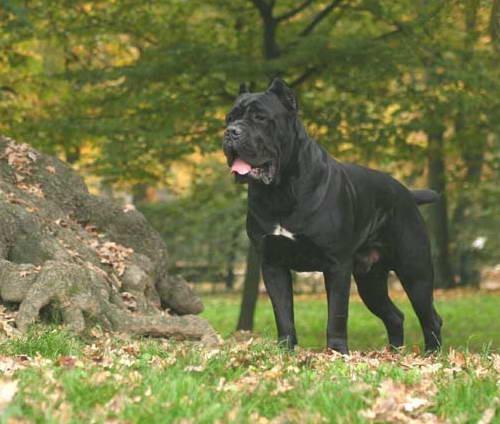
left=0, top=0, right=500, bottom=327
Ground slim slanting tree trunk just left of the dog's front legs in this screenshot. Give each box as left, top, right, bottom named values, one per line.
left=236, top=243, right=260, bottom=331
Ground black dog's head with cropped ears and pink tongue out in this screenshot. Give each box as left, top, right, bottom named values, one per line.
left=223, top=78, right=298, bottom=185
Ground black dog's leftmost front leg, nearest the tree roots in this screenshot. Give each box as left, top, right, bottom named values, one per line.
left=262, top=262, right=297, bottom=349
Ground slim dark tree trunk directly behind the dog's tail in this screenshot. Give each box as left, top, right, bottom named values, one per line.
left=427, top=127, right=453, bottom=288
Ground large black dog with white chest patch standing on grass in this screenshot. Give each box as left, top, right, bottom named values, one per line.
left=223, top=79, right=442, bottom=353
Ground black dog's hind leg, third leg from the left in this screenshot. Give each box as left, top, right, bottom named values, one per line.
left=354, top=263, right=404, bottom=348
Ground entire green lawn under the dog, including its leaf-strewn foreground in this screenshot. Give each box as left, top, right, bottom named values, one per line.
left=0, top=294, right=500, bottom=423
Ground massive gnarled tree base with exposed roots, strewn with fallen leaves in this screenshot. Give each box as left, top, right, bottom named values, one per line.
left=0, top=137, right=218, bottom=343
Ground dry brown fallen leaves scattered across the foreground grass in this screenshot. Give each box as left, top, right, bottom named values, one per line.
left=0, top=330, right=500, bottom=424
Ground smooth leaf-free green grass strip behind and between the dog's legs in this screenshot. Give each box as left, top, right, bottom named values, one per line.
left=203, top=293, right=500, bottom=352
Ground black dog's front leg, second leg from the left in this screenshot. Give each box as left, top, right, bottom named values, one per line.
left=323, top=263, right=352, bottom=354
